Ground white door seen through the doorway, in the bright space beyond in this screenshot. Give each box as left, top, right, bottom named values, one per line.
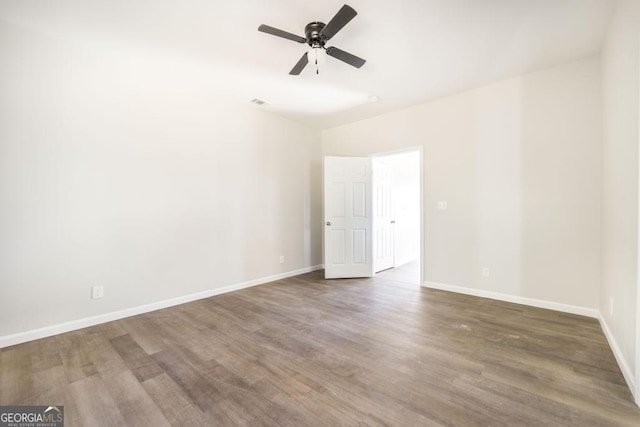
left=373, top=159, right=395, bottom=273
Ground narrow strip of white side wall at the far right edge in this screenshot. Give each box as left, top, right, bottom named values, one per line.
left=600, top=0, right=640, bottom=399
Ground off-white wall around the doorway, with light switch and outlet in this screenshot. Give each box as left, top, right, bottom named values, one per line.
left=322, top=57, right=602, bottom=315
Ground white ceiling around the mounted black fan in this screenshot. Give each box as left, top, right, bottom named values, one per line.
left=0, top=0, right=615, bottom=128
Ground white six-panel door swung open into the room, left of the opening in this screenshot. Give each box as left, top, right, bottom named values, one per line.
left=324, top=157, right=373, bottom=279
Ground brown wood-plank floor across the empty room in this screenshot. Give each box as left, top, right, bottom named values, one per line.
left=0, top=267, right=640, bottom=427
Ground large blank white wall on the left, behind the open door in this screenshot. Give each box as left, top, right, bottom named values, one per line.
left=0, top=22, right=321, bottom=344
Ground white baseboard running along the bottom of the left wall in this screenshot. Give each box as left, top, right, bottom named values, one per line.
left=0, top=265, right=323, bottom=348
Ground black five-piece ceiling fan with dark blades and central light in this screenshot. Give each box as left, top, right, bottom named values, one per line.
left=258, top=4, right=366, bottom=76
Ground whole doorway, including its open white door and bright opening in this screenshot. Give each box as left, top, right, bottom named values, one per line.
left=323, top=147, right=424, bottom=285
